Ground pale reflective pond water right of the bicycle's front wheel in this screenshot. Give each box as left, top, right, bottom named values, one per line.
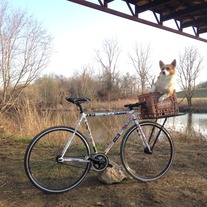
left=165, top=113, right=207, bottom=140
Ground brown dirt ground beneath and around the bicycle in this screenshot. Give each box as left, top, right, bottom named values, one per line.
left=0, top=135, right=207, bottom=207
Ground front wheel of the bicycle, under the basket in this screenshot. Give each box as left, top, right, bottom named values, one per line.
left=120, top=122, right=174, bottom=181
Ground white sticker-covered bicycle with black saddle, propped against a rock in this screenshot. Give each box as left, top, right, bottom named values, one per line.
left=24, top=98, right=174, bottom=193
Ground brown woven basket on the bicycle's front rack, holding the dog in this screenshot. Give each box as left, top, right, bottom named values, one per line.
left=138, top=91, right=179, bottom=119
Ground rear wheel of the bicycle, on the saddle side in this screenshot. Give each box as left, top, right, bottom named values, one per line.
left=24, top=126, right=91, bottom=193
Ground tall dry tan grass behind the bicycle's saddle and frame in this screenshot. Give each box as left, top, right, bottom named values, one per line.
left=1, top=100, right=136, bottom=140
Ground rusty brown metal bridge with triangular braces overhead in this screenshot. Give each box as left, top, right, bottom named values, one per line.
left=67, top=0, right=207, bottom=43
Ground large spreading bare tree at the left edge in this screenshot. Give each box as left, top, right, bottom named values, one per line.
left=0, top=1, right=52, bottom=112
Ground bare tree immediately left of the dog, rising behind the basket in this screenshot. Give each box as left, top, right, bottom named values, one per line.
left=129, top=43, right=152, bottom=93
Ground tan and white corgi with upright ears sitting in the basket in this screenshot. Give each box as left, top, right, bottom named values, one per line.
left=150, top=60, right=176, bottom=102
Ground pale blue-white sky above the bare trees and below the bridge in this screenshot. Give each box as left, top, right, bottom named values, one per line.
left=8, top=0, right=207, bottom=82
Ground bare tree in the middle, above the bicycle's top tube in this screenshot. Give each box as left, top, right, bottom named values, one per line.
left=95, top=39, right=120, bottom=101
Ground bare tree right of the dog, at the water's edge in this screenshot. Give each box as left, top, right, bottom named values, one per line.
left=177, top=46, right=203, bottom=109
